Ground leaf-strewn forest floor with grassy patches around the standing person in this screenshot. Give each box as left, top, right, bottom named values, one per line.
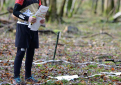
left=0, top=9, right=121, bottom=85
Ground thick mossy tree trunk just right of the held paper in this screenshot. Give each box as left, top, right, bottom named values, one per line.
left=49, top=0, right=57, bottom=22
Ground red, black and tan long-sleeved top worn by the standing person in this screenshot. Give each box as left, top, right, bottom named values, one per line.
left=13, top=0, right=41, bottom=25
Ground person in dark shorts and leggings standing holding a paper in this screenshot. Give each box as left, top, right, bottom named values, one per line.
left=13, top=0, right=45, bottom=84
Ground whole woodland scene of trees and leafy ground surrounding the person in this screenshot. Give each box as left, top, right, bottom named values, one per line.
left=0, top=0, right=121, bottom=85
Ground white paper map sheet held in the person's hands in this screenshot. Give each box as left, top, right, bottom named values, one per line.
left=28, top=5, right=49, bottom=31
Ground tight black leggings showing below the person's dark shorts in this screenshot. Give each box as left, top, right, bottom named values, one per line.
left=14, top=47, right=35, bottom=79
